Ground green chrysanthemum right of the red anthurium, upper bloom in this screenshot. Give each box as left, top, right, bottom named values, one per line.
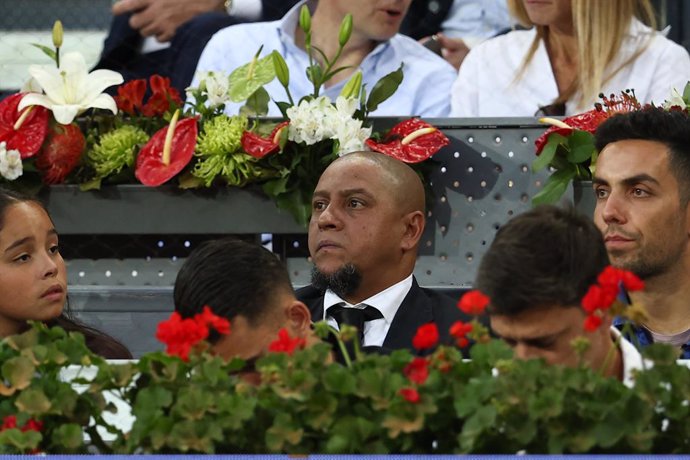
left=196, top=115, right=248, bottom=157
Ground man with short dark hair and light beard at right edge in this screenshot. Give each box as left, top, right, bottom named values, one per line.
left=594, top=108, right=690, bottom=359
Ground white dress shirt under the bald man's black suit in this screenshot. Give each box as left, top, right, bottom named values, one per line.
left=322, top=275, right=412, bottom=347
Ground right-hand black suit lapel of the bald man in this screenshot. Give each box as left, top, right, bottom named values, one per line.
left=383, top=278, right=434, bottom=350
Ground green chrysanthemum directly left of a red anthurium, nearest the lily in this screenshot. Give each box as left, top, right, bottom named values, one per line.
left=87, top=125, right=149, bottom=178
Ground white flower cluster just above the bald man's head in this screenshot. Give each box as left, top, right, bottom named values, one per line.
left=287, top=96, right=371, bottom=155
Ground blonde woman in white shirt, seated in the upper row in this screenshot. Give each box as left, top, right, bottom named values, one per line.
left=451, top=0, right=690, bottom=117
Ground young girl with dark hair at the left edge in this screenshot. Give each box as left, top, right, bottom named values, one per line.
left=0, top=189, right=132, bottom=359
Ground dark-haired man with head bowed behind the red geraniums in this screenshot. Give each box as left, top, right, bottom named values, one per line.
left=475, top=206, right=642, bottom=382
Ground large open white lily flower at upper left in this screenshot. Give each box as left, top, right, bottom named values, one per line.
left=18, top=52, right=124, bottom=125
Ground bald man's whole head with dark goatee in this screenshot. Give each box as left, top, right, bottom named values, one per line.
left=309, top=152, right=424, bottom=302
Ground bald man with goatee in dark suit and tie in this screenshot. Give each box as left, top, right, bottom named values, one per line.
left=297, top=152, right=468, bottom=350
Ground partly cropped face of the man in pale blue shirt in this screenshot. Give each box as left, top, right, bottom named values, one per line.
left=326, top=0, right=412, bottom=41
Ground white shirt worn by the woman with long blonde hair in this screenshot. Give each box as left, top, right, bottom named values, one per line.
left=451, top=20, right=690, bottom=117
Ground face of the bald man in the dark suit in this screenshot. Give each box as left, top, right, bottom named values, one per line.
left=309, top=157, right=406, bottom=292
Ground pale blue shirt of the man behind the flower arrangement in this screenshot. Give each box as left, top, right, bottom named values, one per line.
left=188, top=2, right=457, bottom=117
